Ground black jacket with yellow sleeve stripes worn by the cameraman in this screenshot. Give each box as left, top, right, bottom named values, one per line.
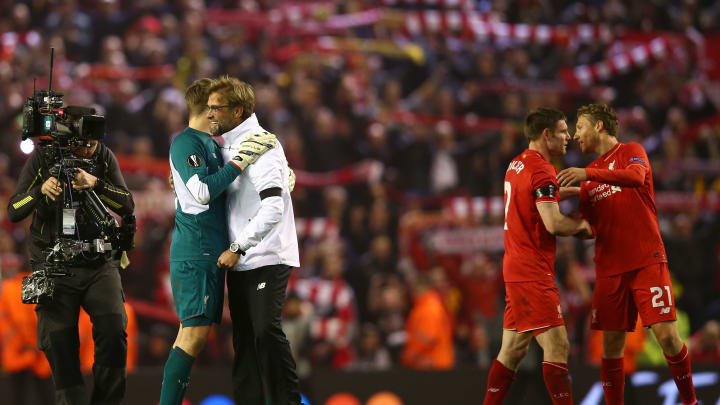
left=7, top=143, right=135, bottom=262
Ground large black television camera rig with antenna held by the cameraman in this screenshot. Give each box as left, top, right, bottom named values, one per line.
left=22, top=49, right=136, bottom=304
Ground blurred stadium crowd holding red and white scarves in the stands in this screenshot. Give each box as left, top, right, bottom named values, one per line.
left=0, top=0, right=720, bottom=386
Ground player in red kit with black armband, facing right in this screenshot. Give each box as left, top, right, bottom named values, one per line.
left=484, top=108, right=592, bottom=405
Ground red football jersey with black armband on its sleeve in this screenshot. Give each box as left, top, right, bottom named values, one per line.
left=503, top=149, right=560, bottom=282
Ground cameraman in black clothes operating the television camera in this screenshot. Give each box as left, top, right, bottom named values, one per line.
left=8, top=140, right=134, bottom=405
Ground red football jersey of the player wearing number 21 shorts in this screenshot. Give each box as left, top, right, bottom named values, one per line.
left=580, top=142, right=667, bottom=277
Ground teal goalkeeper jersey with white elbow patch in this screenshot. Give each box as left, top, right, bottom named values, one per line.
left=170, top=128, right=240, bottom=261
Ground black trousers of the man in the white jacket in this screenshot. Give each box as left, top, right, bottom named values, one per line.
left=227, top=265, right=300, bottom=405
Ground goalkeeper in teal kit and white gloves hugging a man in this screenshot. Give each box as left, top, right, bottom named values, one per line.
left=160, top=79, right=276, bottom=405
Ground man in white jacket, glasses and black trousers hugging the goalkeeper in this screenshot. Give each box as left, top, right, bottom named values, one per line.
left=208, top=77, right=300, bottom=405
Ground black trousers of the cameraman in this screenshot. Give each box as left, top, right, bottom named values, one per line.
left=35, top=261, right=127, bottom=405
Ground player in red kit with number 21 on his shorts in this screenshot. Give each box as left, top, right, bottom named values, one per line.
left=557, top=104, right=697, bottom=405
